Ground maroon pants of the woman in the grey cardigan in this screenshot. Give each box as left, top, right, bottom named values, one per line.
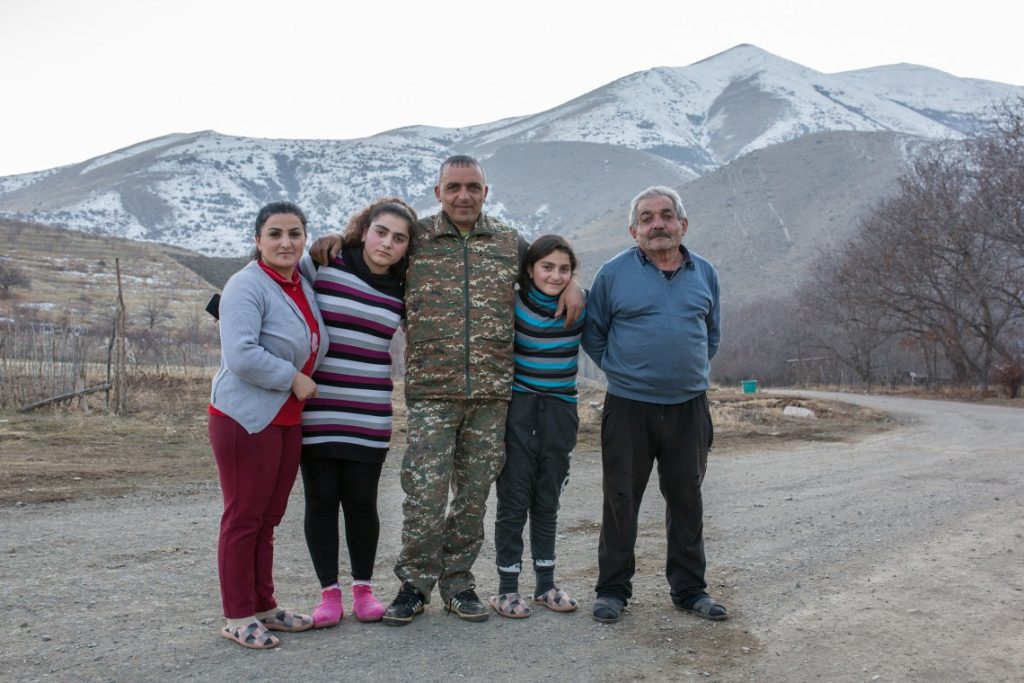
left=210, top=415, right=302, bottom=618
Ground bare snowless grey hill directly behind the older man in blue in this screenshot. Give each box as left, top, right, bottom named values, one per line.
left=567, top=132, right=922, bottom=306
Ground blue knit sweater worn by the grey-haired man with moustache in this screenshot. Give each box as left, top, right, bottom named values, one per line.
left=583, top=247, right=722, bottom=404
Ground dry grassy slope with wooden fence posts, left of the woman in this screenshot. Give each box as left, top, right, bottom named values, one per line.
left=0, top=219, right=226, bottom=410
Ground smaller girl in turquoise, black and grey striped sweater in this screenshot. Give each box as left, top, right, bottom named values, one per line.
left=490, top=234, right=586, bottom=618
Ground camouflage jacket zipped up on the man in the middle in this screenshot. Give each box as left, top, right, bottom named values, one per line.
left=406, top=212, right=519, bottom=398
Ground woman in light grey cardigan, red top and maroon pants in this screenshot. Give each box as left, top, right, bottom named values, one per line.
left=208, top=202, right=328, bottom=649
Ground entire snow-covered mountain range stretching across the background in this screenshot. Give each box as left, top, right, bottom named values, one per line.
left=0, top=45, right=1024, bottom=255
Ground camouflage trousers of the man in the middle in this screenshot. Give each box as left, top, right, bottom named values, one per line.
left=394, top=399, right=508, bottom=602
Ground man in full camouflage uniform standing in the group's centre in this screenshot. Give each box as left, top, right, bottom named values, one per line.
left=313, top=155, right=583, bottom=626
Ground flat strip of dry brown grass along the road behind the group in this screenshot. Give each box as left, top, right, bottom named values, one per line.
left=0, top=374, right=891, bottom=507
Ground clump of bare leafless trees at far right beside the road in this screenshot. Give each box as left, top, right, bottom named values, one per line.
left=809, top=108, right=1024, bottom=389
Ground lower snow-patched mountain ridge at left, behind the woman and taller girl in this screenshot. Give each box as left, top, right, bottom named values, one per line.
left=0, top=131, right=450, bottom=255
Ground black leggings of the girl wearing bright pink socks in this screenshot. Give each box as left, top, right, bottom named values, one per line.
left=300, top=458, right=384, bottom=587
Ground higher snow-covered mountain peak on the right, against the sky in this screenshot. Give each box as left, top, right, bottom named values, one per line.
left=438, top=45, right=1024, bottom=175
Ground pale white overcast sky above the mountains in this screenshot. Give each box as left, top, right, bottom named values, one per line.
left=0, top=0, right=1024, bottom=175
